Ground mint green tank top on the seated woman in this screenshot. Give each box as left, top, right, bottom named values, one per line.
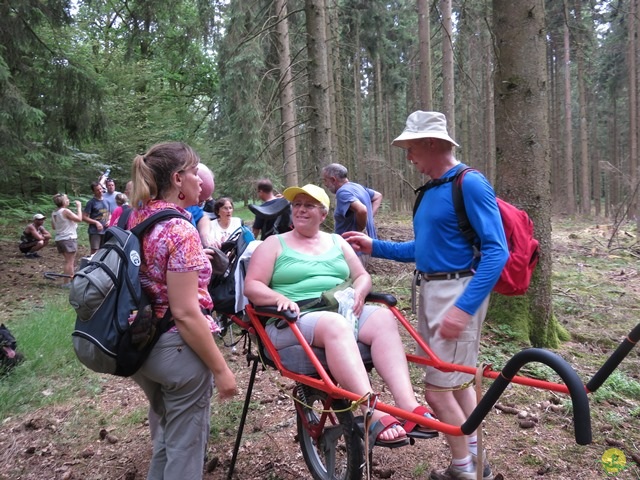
left=269, top=234, right=350, bottom=302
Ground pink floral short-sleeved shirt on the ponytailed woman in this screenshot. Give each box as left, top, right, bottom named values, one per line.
left=128, top=200, right=220, bottom=333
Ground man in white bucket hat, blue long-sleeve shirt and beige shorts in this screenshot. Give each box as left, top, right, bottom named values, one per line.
left=344, top=111, right=509, bottom=480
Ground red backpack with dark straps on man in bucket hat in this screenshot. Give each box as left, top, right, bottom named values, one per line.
left=413, top=167, right=540, bottom=295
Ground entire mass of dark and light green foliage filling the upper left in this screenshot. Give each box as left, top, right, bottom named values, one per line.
left=0, top=0, right=230, bottom=198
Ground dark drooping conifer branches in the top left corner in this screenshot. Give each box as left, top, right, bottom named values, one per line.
left=0, top=0, right=104, bottom=196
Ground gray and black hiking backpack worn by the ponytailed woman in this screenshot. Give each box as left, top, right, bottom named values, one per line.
left=69, top=209, right=185, bottom=377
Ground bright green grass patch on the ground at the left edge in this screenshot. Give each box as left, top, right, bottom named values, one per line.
left=0, top=296, right=101, bottom=421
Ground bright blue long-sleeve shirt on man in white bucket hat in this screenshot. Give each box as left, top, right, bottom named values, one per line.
left=373, top=164, right=509, bottom=315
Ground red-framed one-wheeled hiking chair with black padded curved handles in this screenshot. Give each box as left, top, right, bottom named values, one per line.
left=214, top=282, right=640, bottom=480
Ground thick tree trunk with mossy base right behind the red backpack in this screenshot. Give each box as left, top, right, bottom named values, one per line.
left=492, top=0, right=558, bottom=347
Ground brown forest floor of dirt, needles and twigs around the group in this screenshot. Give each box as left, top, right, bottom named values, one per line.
left=0, top=216, right=640, bottom=480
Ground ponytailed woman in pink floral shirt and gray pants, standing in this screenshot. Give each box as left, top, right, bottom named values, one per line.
left=128, top=142, right=237, bottom=479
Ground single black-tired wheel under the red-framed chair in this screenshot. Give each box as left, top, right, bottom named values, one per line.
left=294, top=384, right=364, bottom=480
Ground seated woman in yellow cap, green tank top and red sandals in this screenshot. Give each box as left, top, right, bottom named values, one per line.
left=244, top=184, right=433, bottom=447
